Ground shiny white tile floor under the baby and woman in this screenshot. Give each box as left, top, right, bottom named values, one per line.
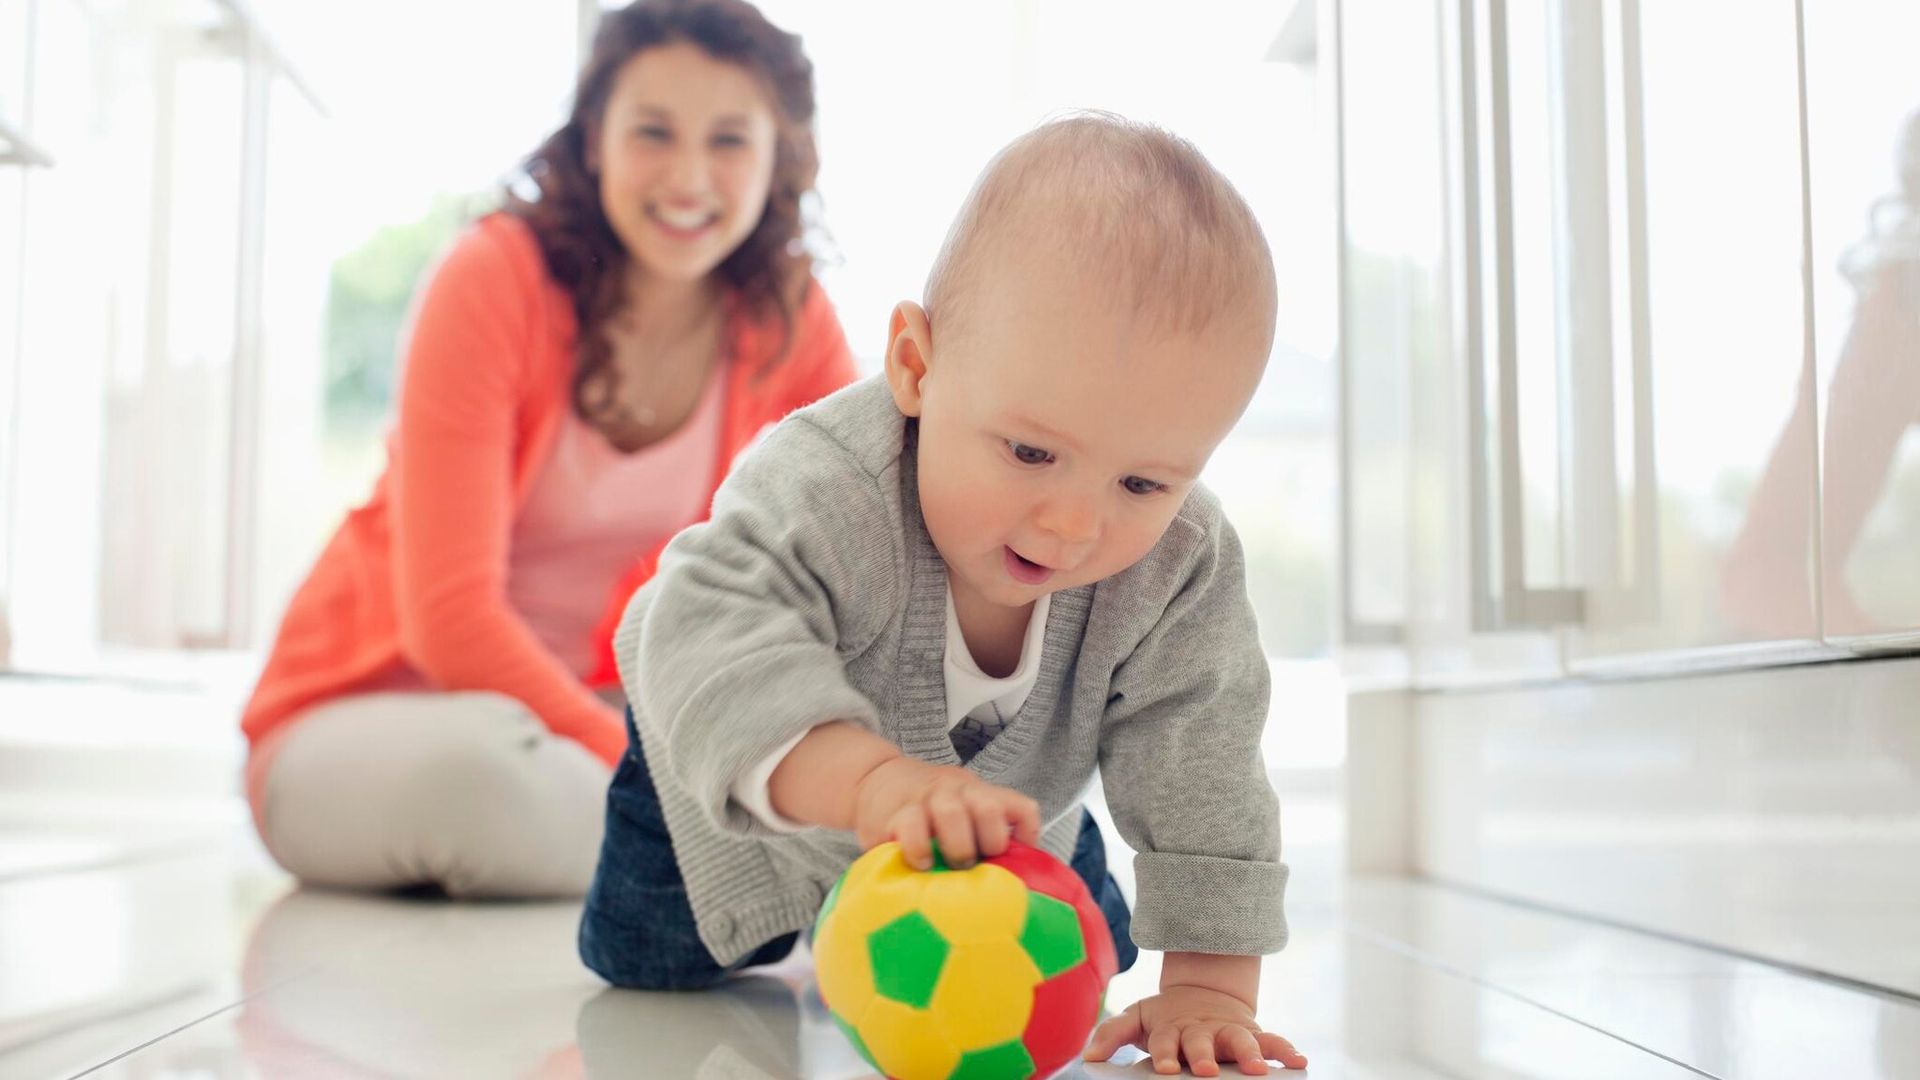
left=11, top=814, right=1920, bottom=1080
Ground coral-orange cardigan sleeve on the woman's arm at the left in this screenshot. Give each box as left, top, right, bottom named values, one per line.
left=392, top=223, right=626, bottom=763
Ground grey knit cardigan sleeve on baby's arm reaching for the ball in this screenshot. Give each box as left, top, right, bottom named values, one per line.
left=614, top=417, right=899, bottom=834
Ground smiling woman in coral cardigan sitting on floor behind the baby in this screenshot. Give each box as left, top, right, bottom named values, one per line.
left=242, top=0, right=854, bottom=896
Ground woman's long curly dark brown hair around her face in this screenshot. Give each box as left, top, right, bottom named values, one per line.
left=505, top=0, right=820, bottom=419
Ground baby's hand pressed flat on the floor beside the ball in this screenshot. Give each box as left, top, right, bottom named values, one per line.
left=1087, top=986, right=1308, bottom=1076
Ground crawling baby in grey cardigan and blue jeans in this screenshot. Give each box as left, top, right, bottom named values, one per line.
left=580, top=115, right=1306, bottom=1076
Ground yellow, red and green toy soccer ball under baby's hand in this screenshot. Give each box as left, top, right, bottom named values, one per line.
left=814, top=842, right=1116, bottom=1080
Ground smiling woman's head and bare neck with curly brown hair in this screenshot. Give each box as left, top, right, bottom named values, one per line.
left=511, top=0, right=820, bottom=448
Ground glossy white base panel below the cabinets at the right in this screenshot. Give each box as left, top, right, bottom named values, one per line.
left=1397, top=645, right=1920, bottom=994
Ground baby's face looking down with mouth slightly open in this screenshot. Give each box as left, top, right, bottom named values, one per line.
left=902, top=257, right=1269, bottom=607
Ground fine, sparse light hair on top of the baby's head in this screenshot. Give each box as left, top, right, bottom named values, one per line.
left=924, top=111, right=1275, bottom=332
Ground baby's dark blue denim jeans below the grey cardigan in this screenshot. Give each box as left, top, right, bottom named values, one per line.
left=580, top=711, right=1139, bottom=990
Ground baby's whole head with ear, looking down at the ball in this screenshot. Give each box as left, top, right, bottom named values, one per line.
left=887, top=115, right=1275, bottom=607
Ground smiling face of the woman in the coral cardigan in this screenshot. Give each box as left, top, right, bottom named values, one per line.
left=588, top=42, right=776, bottom=281
